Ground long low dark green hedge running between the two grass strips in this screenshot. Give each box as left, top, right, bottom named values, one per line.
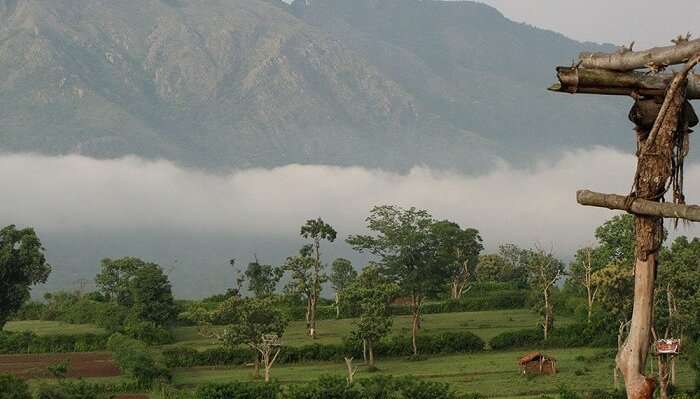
left=163, top=332, right=484, bottom=368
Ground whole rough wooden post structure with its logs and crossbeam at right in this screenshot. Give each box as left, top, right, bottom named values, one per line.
left=550, top=36, right=700, bottom=399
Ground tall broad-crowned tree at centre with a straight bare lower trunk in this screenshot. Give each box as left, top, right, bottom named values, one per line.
left=347, top=205, right=451, bottom=355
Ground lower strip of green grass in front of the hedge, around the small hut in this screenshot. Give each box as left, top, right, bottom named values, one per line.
left=173, top=348, right=694, bottom=399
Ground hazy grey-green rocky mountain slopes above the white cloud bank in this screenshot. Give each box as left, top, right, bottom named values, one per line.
left=0, top=0, right=628, bottom=170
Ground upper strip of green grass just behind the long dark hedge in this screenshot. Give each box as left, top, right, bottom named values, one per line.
left=168, top=309, right=571, bottom=349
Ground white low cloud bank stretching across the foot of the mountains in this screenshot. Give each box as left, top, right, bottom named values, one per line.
left=0, top=148, right=700, bottom=256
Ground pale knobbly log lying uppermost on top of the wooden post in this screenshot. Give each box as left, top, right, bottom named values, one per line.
left=579, top=38, right=700, bottom=71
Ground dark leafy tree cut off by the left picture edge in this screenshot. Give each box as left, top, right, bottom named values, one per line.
left=0, top=225, right=51, bottom=330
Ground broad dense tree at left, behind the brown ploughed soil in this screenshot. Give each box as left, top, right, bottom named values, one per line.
left=95, top=257, right=177, bottom=326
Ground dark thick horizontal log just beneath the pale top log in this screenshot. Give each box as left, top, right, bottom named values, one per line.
left=549, top=66, right=700, bottom=100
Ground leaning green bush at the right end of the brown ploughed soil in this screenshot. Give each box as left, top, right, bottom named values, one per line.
left=107, top=333, right=170, bottom=388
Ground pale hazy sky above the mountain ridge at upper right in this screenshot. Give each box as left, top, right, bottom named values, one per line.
left=479, top=0, right=700, bottom=48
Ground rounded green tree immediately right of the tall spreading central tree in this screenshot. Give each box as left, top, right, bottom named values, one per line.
left=432, top=220, right=484, bottom=299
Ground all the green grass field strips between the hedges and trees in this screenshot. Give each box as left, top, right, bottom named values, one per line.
left=6, top=310, right=694, bottom=399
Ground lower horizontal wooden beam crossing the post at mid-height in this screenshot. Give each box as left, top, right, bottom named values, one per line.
left=576, top=190, right=700, bottom=222
